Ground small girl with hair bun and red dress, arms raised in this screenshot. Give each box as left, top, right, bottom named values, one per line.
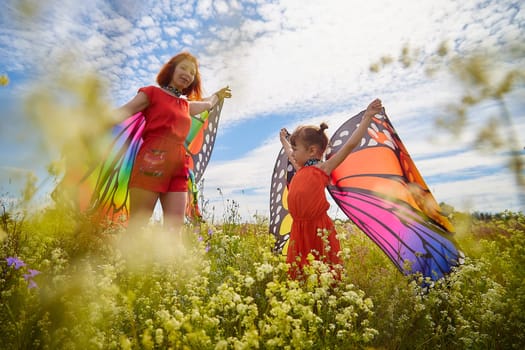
left=280, top=99, right=383, bottom=278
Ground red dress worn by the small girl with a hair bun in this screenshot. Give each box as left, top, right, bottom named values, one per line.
left=286, top=166, right=342, bottom=278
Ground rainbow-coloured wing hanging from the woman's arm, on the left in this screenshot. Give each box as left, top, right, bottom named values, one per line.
left=81, top=113, right=145, bottom=222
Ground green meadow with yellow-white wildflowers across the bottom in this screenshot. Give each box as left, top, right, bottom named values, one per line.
left=0, top=198, right=525, bottom=349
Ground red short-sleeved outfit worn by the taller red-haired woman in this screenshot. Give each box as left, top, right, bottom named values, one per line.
left=129, top=86, right=191, bottom=193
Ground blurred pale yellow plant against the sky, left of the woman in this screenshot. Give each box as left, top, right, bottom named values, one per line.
left=25, top=58, right=115, bottom=206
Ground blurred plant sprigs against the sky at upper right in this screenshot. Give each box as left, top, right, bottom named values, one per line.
left=370, top=43, right=525, bottom=206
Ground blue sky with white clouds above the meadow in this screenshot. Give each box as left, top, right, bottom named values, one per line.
left=0, top=0, right=525, bottom=219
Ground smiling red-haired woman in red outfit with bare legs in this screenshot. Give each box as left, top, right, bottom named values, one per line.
left=119, top=52, right=231, bottom=229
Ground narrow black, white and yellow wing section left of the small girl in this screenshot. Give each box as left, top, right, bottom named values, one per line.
left=269, top=148, right=295, bottom=255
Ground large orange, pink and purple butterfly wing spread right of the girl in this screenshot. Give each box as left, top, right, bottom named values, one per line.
left=327, top=112, right=460, bottom=280
